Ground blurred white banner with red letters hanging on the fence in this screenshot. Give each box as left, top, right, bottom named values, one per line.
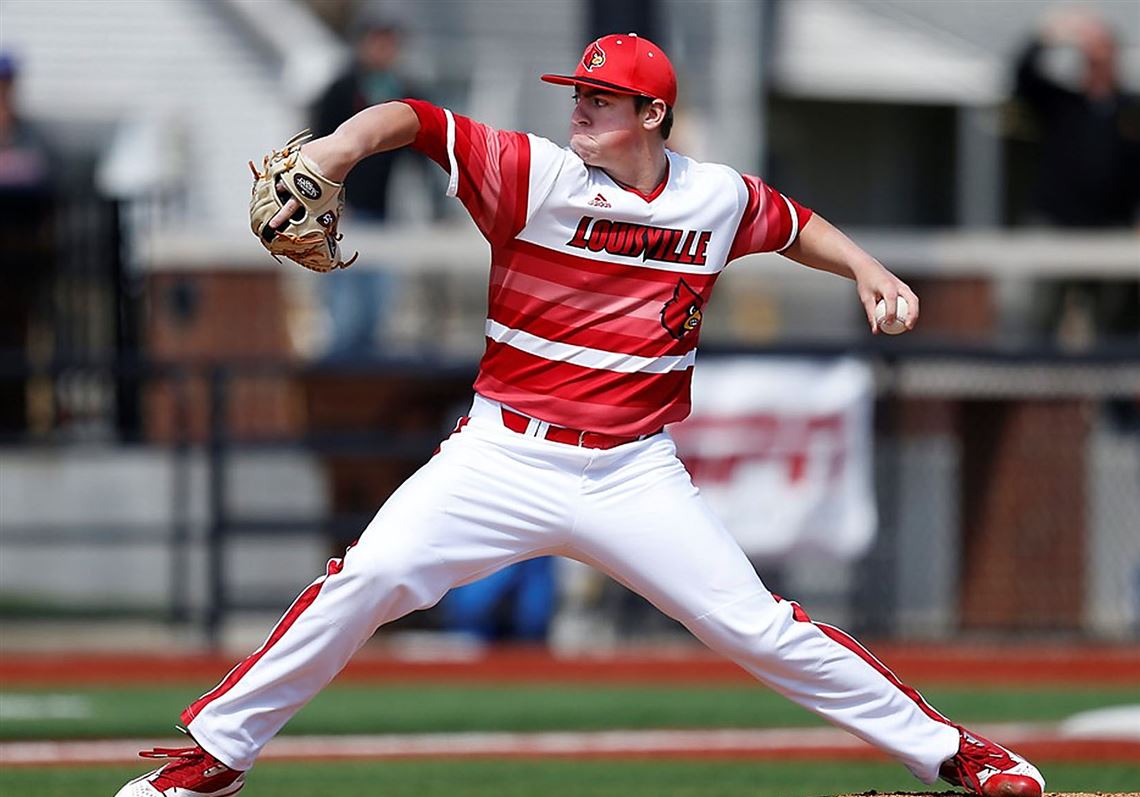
left=669, top=357, right=878, bottom=560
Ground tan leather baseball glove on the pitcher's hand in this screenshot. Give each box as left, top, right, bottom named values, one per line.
left=250, top=130, right=357, bottom=274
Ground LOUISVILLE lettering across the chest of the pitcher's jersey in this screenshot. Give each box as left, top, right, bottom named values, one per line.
left=567, top=215, right=713, bottom=266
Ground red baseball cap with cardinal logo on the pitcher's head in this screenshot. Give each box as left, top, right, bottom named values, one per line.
left=543, top=33, right=677, bottom=108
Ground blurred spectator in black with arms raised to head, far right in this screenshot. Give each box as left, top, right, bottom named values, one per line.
left=1015, top=9, right=1140, bottom=342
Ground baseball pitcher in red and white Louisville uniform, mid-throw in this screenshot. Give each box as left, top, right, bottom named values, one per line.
left=119, top=33, right=1044, bottom=797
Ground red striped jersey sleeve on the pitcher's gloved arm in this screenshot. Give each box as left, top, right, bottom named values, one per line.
left=402, top=99, right=531, bottom=244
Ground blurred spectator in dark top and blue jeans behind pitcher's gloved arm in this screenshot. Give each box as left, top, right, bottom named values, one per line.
left=311, top=9, right=423, bottom=357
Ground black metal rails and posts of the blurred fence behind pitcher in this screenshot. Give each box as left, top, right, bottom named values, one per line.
left=0, top=340, right=1140, bottom=641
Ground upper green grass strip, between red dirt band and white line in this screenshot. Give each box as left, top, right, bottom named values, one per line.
left=0, top=683, right=1140, bottom=739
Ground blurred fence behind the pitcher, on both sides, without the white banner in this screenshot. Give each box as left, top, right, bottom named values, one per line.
left=0, top=348, right=1140, bottom=643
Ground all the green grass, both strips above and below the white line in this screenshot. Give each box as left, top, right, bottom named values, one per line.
left=0, top=683, right=1140, bottom=797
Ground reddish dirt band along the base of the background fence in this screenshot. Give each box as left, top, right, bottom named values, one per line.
left=0, top=644, right=1140, bottom=685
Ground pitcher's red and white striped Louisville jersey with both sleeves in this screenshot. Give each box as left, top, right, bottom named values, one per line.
left=405, top=100, right=811, bottom=434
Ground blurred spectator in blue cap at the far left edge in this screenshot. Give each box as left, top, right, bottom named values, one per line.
left=0, top=52, right=55, bottom=434
